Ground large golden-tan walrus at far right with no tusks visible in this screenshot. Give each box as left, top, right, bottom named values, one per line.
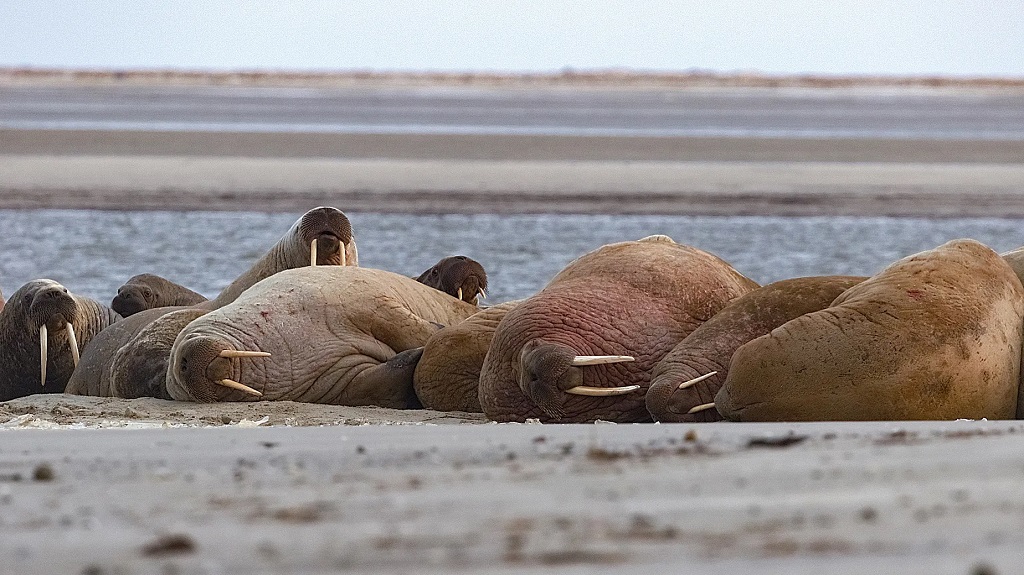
left=715, top=239, right=1024, bottom=422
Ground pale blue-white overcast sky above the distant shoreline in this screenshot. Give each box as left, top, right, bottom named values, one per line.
left=0, top=0, right=1024, bottom=77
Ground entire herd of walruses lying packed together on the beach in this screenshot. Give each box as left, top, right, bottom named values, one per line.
left=0, top=208, right=1024, bottom=423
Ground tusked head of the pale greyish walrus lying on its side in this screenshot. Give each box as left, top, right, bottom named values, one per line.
left=167, top=329, right=270, bottom=403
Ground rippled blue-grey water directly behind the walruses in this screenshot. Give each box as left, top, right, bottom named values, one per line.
left=0, top=210, right=1024, bottom=303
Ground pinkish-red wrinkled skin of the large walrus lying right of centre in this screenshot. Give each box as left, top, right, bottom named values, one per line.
left=479, top=236, right=757, bottom=423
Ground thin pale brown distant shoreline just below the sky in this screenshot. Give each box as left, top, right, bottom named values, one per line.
left=6, top=68, right=1024, bottom=91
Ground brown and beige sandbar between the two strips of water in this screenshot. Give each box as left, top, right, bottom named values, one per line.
left=0, top=130, right=1024, bottom=217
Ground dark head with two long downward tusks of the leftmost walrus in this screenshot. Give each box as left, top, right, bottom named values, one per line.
left=4, top=279, right=79, bottom=387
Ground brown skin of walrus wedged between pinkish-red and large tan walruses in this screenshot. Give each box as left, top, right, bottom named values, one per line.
left=645, top=275, right=866, bottom=423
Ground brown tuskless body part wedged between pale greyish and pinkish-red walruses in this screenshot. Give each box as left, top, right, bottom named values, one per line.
left=413, top=301, right=519, bottom=413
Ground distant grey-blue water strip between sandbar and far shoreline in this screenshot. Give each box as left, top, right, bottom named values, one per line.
left=6, top=86, right=1024, bottom=140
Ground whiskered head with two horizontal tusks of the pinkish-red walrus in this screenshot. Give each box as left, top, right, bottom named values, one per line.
left=519, top=339, right=640, bottom=419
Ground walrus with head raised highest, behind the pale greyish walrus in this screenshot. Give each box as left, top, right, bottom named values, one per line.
left=67, top=207, right=358, bottom=397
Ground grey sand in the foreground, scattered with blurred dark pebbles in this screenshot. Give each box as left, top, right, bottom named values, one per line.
left=0, top=396, right=1024, bottom=574
